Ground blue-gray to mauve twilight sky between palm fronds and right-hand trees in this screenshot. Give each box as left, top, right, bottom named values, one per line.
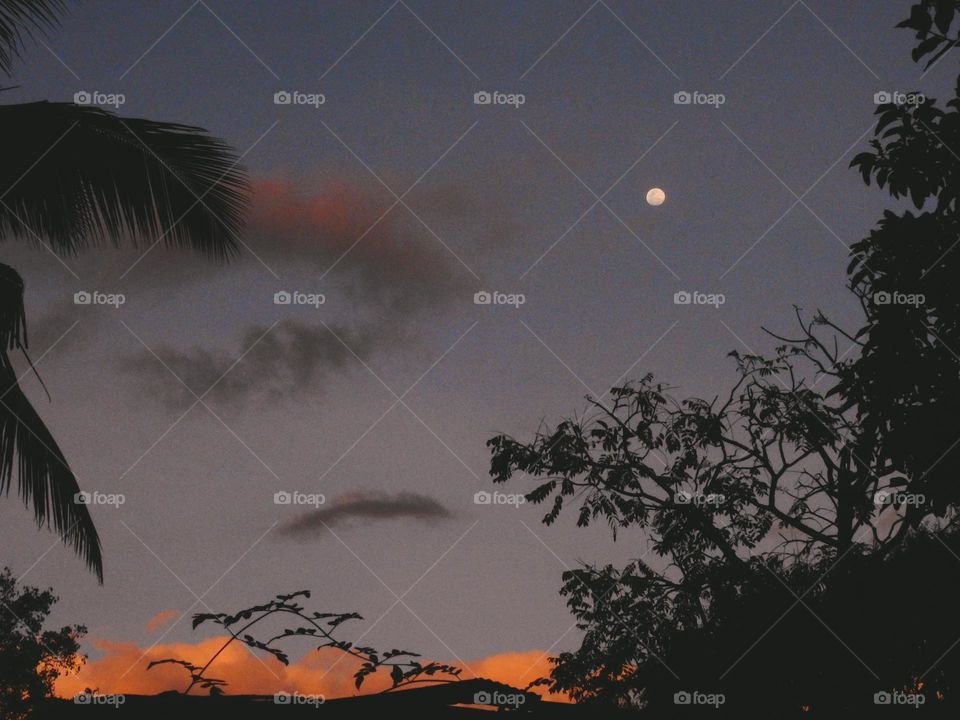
left=0, top=0, right=953, bottom=696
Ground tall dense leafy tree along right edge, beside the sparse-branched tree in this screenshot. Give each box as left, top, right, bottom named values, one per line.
left=836, top=2, right=960, bottom=531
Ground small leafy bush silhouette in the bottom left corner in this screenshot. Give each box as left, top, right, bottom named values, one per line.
left=0, top=568, right=87, bottom=720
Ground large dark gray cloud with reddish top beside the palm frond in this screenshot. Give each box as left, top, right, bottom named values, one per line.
left=121, top=182, right=502, bottom=405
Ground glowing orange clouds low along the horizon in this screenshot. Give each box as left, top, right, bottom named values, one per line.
left=55, top=636, right=565, bottom=700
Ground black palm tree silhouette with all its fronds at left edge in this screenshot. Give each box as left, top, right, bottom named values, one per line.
left=0, top=0, right=248, bottom=582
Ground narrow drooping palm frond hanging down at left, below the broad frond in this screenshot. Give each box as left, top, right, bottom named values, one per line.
left=0, top=264, right=103, bottom=582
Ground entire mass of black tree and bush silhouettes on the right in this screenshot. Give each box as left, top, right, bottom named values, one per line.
left=487, top=0, right=960, bottom=717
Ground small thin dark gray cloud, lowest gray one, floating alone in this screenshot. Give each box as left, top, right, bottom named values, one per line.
left=280, top=491, right=453, bottom=536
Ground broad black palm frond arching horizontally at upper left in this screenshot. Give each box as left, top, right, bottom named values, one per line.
left=0, top=102, right=248, bottom=260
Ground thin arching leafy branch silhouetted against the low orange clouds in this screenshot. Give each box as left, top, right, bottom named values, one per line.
left=147, top=590, right=461, bottom=695
